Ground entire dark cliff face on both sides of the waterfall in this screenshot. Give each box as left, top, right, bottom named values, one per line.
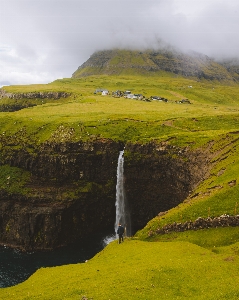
left=0, top=140, right=212, bottom=250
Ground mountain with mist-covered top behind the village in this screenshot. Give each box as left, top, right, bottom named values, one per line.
left=72, top=48, right=239, bottom=81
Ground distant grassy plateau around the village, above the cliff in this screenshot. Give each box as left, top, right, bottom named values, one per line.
left=0, top=76, right=239, bottom=144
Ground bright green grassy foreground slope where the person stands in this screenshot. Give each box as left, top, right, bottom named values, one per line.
left=0, top=240, right=239, bottom=300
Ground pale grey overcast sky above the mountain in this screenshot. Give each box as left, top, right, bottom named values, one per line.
left=0, top=0, right=239, bottom=86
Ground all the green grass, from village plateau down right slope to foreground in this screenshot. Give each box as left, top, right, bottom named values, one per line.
left=0, top=74, right=239, bottom=300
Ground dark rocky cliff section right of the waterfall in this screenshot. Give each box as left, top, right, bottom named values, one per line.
left=125, top=143, right=210, bottom=230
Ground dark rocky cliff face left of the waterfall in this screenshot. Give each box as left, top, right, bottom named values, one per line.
left=0, top=140, right=122, bottom=250
